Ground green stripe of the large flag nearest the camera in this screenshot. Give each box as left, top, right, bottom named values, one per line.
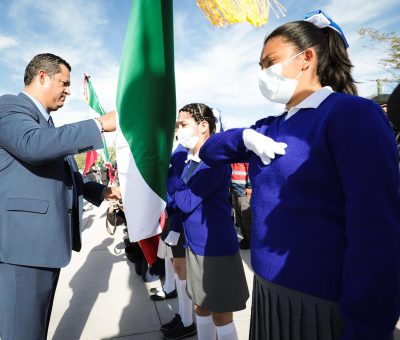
left=117, top=0, right=176, bottom=199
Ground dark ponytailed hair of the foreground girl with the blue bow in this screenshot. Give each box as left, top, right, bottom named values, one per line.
left=264, top=21, right=357, bottom=95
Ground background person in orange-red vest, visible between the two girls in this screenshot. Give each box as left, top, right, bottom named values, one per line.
left=231, top=163, right=251, bottom=249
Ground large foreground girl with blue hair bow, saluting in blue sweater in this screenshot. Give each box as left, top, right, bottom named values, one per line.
left=200, top=11, right=400, bottom=340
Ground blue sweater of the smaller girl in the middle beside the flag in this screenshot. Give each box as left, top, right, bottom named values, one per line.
left=168, top=161, right=239, bottom=256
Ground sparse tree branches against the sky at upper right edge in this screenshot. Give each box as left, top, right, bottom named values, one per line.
left=358, top=28, right=400, bottom=81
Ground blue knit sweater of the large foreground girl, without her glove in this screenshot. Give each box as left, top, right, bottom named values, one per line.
left=200, top=93, right=400, bottom=340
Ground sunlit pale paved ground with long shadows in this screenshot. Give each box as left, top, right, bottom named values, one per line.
left=48, top=203, right=400, bottom=340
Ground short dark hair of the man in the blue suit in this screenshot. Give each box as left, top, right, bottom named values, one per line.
left=24, top=53, right=71, bottom=85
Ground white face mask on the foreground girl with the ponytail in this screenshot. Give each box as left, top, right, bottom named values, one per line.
left=258, top=51, right=304, bottom=104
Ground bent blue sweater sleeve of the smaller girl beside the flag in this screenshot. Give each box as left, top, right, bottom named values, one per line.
left=174, top=166, right=230, bottom=214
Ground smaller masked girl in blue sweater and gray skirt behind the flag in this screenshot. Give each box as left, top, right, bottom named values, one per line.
left=168, top=104, right=249, bottom=340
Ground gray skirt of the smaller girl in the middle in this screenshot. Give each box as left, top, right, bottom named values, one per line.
left=186, top=247, right=249, bottom=313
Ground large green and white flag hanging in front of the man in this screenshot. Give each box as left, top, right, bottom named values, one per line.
left=117, top=0, right=176, bottom=255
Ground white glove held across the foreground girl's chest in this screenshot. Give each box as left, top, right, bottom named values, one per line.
left=243, top=129, right=287, bottom=165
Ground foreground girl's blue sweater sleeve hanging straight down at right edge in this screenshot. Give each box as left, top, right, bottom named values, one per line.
left=327, top=101, right=400, bottom=340
